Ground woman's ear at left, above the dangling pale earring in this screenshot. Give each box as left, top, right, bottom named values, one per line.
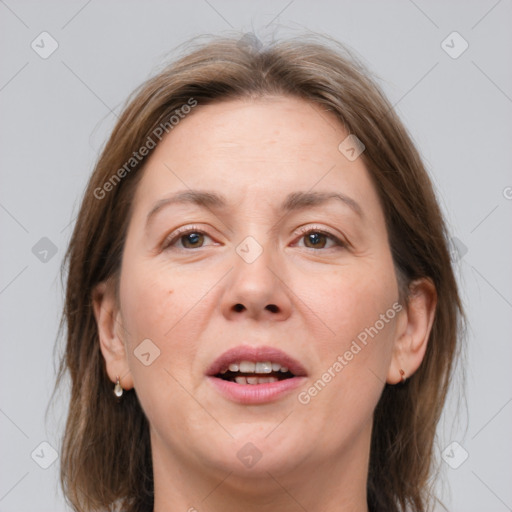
left=92, top=280, right=133, bottom=389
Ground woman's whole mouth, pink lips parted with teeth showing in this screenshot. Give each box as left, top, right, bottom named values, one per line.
left=206, top=346, right=307, bottom=404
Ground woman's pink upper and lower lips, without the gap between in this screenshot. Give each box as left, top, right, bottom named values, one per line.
left=206, top=345, right=307, bottom=405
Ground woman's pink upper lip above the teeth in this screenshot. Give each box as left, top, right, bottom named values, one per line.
left=206, top=345, right=307, bottom=377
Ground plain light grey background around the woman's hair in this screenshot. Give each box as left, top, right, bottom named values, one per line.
left=0, top=0, right=512, bottom=512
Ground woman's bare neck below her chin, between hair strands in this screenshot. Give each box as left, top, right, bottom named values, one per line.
left=152, top=420, right=371, bottom=512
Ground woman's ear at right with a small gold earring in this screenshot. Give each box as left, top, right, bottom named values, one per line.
left=386, top=278, right=437, bottom=384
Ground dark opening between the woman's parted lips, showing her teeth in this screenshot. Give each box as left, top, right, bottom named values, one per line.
left=215, top=361, right=295, bottom=384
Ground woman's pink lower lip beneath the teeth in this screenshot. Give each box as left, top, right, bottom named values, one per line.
left=208, top=377, right=306, bottom=405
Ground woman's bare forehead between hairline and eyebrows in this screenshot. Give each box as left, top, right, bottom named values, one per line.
left=130, top=96, right=377, bottom=221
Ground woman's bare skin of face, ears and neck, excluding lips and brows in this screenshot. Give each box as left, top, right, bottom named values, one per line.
left=94, top=96, right=436, bottom=512
